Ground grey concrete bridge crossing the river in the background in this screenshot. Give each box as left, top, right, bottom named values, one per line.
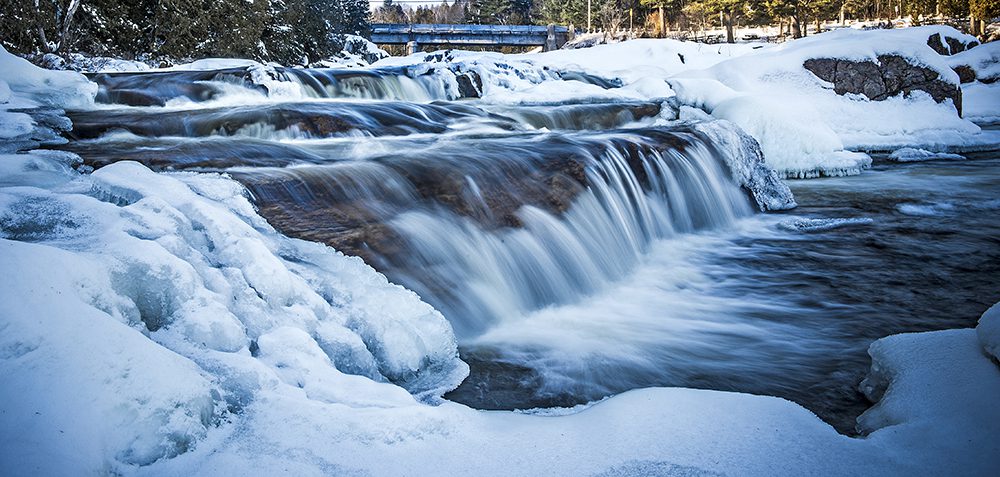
left=372, top=23, right=573, bottom=54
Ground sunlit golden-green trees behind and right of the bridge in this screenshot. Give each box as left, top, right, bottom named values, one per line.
left=373, top=0, right=1000, bottom=42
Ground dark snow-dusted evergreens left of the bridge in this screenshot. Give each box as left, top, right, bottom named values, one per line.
left=0, top=0, right=370, bottom=65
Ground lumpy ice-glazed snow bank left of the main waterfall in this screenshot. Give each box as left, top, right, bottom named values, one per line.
left=0, top=157, right=468, bottom=475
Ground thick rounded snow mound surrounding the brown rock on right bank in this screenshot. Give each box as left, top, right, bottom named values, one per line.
left=669, top=26, right=1000, bottom=177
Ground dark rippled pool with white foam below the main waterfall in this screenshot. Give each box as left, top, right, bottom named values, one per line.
left=447, top=153, right=1000, bottom=434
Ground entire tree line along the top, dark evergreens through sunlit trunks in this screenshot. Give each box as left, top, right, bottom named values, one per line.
left=0, top=0, right=1000, bottom=65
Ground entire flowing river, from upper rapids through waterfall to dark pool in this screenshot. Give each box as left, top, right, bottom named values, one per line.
left=58, top=64, right=1000, bottom=433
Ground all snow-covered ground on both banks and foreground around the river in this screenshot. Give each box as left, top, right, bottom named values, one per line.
left=0, top=27, right=1000, bottom=475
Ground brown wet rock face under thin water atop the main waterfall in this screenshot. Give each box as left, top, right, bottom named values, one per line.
left=232, top=131, right=687, bottom=264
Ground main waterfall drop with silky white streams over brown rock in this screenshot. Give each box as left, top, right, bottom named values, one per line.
left=233, top=131, right=754, bottom=337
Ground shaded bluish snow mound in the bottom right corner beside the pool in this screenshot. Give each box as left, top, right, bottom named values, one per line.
left=858, top=306, right=1000, bottom=476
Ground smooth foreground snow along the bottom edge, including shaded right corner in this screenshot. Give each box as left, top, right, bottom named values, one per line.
left=125, top=302, right=1000, bottom=476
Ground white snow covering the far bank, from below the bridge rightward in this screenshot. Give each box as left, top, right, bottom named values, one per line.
left=375, top=26, right=1000, bottom=178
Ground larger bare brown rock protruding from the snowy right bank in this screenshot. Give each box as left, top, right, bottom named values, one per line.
left=803, top=55, right=962, bottom=115
